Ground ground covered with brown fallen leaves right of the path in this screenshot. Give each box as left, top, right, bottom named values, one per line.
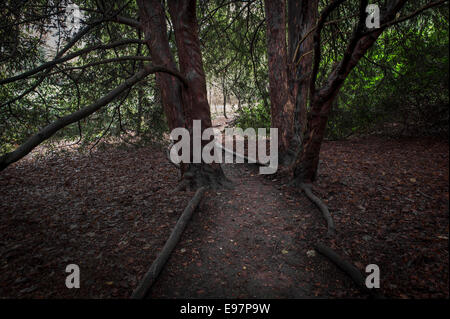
left=315, top=137, right=449, bottom=298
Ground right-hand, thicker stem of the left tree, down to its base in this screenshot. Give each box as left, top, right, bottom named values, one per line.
left=168, top=0, right=228, bottom=188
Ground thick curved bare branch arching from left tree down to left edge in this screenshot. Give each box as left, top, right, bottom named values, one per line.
left=0, top=65, right=187, bottom=171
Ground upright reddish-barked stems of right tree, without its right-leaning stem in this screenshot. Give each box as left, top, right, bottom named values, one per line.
left=265, top=0, right=318, bottom=164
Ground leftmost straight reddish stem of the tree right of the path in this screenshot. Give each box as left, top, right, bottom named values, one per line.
left=264, top=0, right=294, bottom=162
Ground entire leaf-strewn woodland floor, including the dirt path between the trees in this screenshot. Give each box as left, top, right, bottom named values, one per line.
left=0, top=137, right=449, bottom=298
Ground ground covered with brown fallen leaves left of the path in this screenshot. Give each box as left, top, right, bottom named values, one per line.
left=0, top=147, right=192, bottom=298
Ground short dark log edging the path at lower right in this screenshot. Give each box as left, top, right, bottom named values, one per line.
left=314, top=243, right=383, bottom=299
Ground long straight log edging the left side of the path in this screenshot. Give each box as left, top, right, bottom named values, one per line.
left=131, top=187, right=206, bottom=299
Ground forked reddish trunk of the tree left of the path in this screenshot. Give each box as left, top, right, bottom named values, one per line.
left=137, top=0, right=228, bottom=188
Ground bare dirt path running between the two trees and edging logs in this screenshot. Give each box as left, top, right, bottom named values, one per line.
left=151, top=164, right=326, bottom=298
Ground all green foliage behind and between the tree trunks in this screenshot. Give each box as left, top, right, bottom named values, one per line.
left=0, top=0, right=449, bottom=153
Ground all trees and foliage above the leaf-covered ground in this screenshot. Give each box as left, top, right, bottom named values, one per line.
left=0, top=0, right=448, bottom=186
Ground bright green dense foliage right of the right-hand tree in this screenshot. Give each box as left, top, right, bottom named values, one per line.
left=328, top=9, right=449, bottom=138
